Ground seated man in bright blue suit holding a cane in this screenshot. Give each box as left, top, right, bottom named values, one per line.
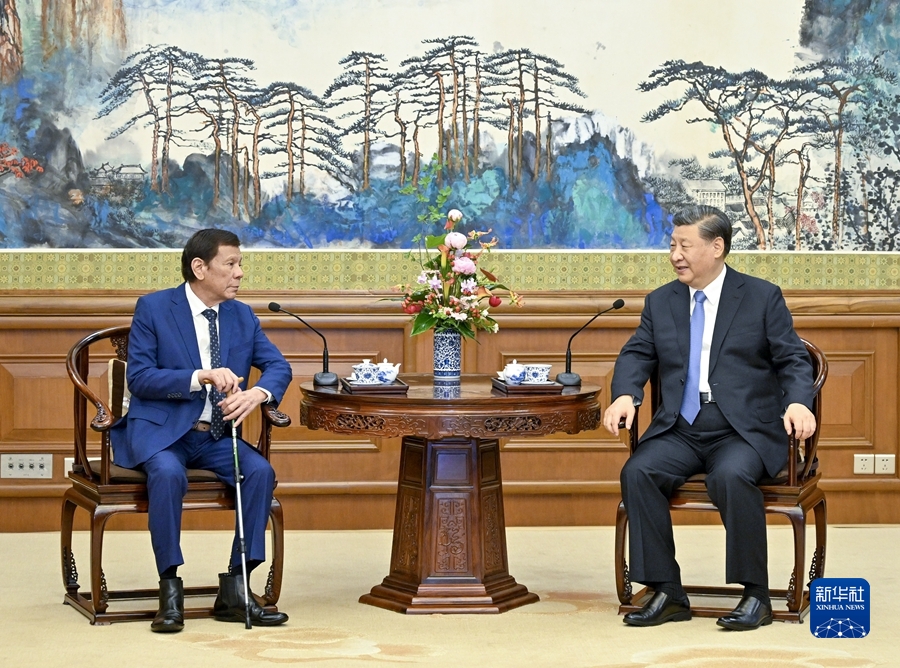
left=112, top=229, right=291, bottom=633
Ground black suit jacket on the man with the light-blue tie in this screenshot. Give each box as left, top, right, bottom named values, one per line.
left=612, top=267, right=813, bottom=476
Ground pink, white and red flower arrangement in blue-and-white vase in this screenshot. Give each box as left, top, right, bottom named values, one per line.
left=400, top=209, right=523, bottom=339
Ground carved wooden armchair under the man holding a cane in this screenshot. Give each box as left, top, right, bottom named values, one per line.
left=60, top=325, right=291, bottom=624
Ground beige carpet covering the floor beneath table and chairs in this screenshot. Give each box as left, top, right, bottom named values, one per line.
left=0, top=526, right=900, bottom=668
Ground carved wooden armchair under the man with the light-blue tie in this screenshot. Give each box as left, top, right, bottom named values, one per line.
left=615, top=340, right=828, bottom=622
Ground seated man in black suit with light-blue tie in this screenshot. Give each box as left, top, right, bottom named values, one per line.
left=603, top=206, right=816, bottom=631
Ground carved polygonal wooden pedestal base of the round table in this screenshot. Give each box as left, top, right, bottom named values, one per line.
left=359, top=436, right=539, bottom=614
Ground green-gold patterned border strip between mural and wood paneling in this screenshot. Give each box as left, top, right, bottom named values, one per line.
left=0, top=250, right=900, bottom=291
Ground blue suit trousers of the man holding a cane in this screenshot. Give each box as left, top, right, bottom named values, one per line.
left=142, top=431, right=275, bottom=573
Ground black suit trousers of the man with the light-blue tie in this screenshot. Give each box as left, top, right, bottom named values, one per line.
left=621, top=403, right=769, bottom=587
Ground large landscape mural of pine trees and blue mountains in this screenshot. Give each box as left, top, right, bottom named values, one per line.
left=0, top=0, right=900, bottom=251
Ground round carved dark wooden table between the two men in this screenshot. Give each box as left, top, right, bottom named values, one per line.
left=300, top=374, right=600, bottom=614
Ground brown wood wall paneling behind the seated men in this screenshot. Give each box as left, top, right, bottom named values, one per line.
left=0, top=291, right=900, bottom=531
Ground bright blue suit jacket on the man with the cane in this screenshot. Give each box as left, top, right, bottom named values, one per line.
left=111, top=283, right=292, bottom=468
